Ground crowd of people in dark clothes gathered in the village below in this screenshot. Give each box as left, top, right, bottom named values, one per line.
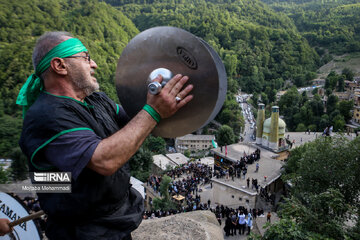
left=143, top=159, right=265, bottom=236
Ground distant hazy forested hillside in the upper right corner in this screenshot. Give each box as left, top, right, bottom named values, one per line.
left=262, top=0, right=360, bottom=55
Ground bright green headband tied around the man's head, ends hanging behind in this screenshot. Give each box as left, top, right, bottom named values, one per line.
left=16, top=38, right=87, bottom=117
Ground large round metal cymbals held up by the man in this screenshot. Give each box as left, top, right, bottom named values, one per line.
left=116, top=27, right=227, bottom=138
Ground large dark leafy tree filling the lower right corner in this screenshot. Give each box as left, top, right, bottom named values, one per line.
left=278, top=136, right=360, bottom=239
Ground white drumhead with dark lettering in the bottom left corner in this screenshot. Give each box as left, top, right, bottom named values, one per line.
left=0, top=192, right=42, bottom=240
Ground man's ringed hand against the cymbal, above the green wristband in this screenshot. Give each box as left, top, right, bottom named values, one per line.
left=147, top=74, right=193, bottom=118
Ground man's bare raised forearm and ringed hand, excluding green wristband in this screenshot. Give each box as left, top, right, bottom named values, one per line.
left=88, top=74, right=193, bottom=176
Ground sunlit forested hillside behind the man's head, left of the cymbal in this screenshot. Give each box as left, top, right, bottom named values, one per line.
left=0, top=0, right=138, bottom=117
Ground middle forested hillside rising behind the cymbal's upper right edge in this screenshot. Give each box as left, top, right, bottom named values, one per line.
left=107, top=0, right=319, bottom=92
